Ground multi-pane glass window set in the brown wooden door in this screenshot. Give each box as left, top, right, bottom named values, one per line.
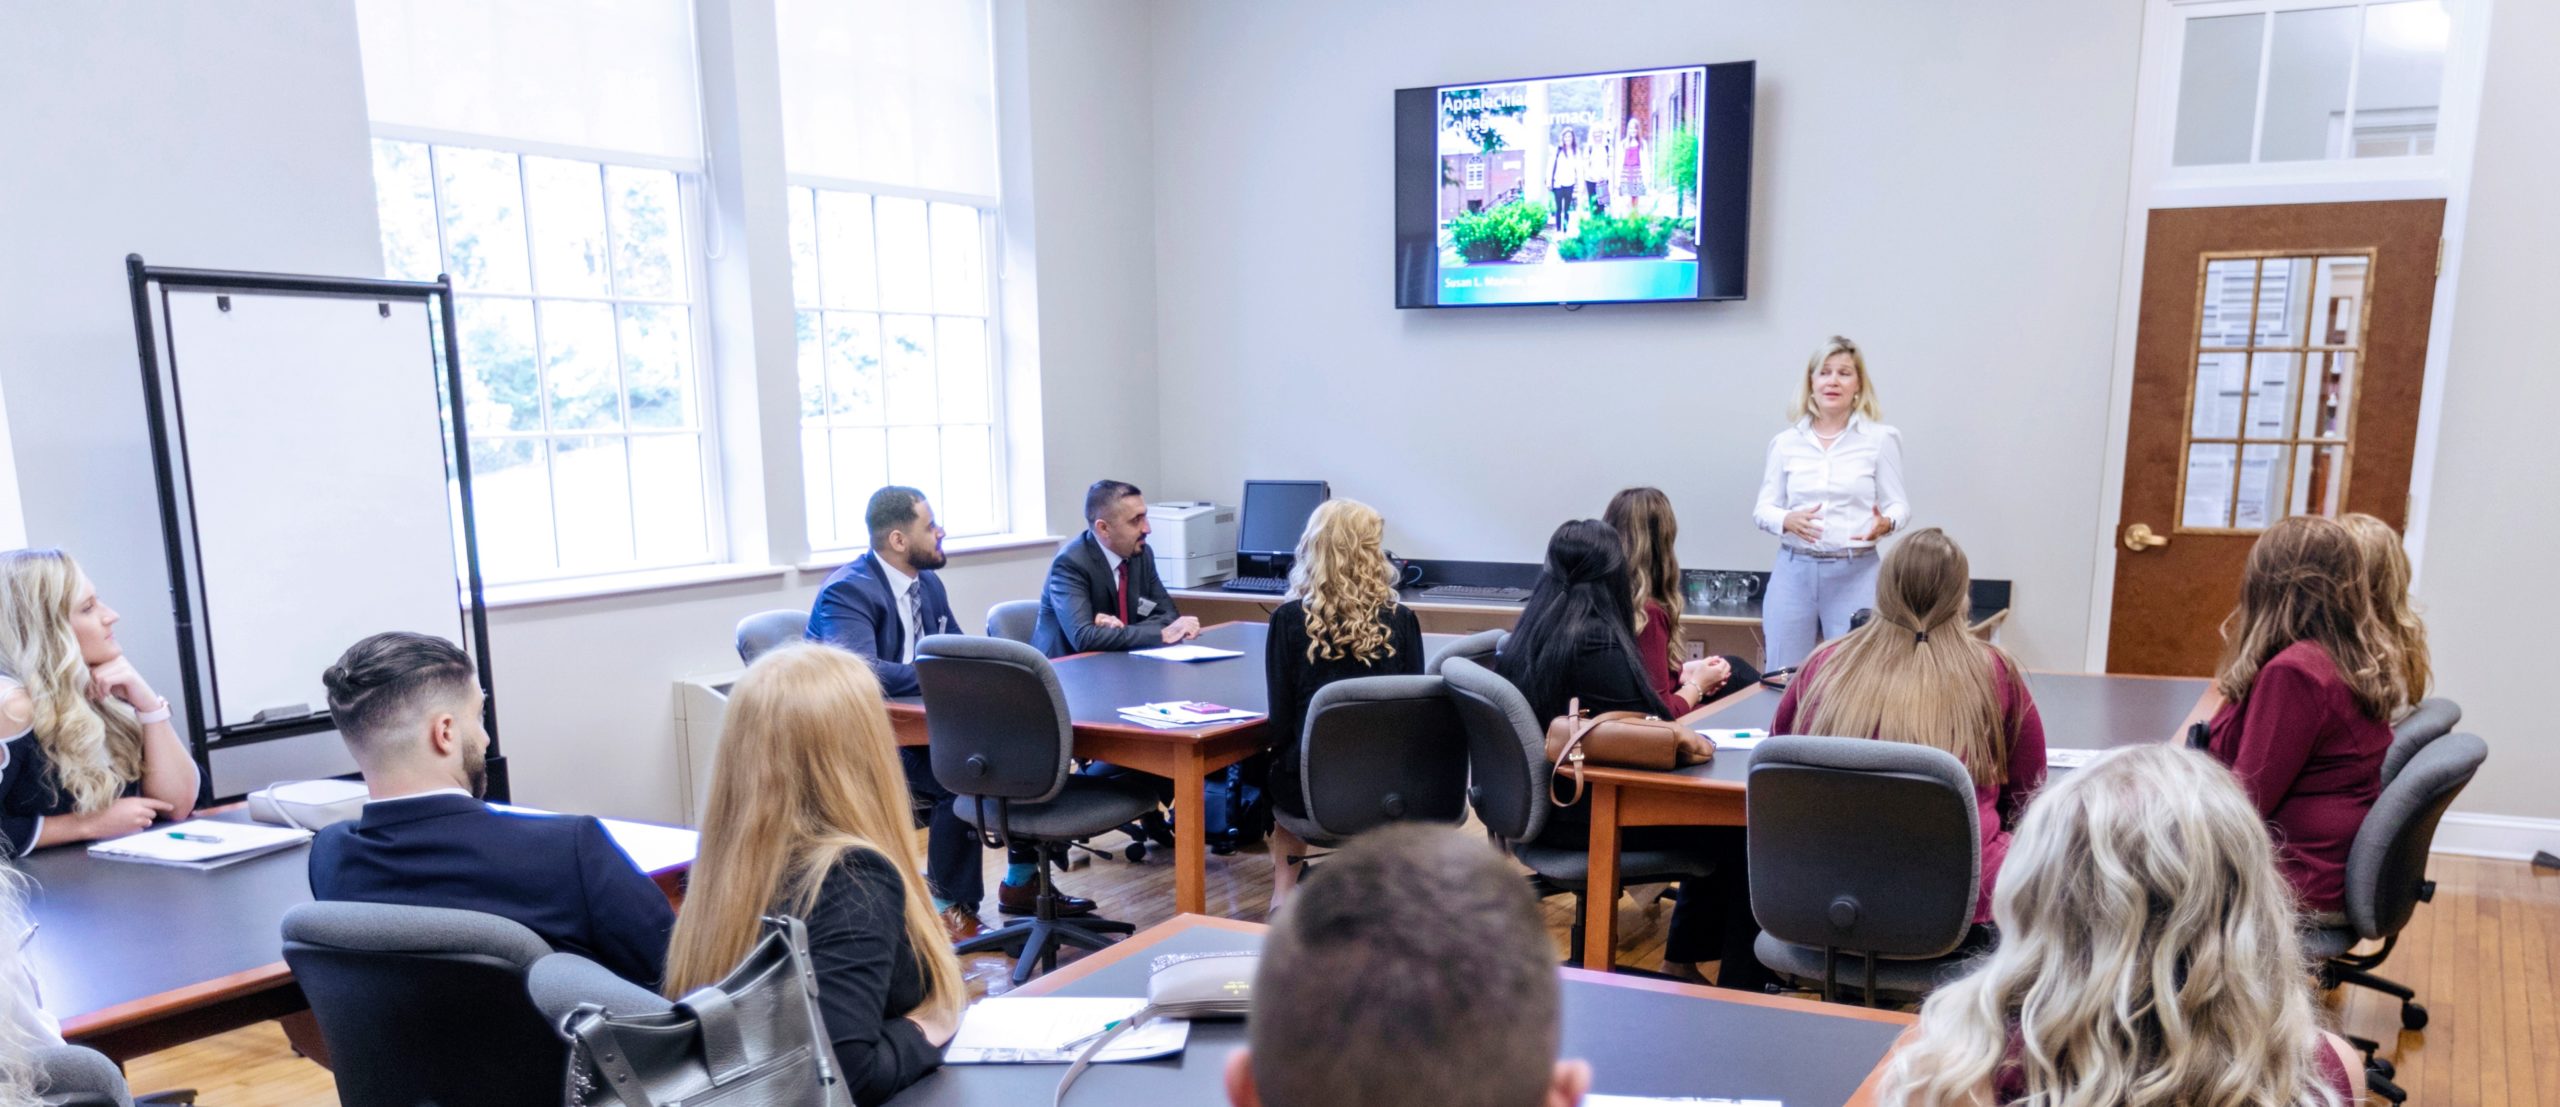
left=2179, top=251, right=2373, bottom=533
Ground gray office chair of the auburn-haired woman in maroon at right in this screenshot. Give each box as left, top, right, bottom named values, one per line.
left=2301, top=732, right=2488, bottom=1102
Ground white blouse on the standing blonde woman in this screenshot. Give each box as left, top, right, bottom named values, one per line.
left=1751, top=415, right=1912, bottom=554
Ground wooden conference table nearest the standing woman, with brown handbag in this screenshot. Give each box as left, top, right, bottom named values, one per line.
left=1582, top=671, right=2212, bottom=971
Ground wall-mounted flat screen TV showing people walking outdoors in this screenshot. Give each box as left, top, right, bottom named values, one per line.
left=1395, top=62, right=1754, bottom=308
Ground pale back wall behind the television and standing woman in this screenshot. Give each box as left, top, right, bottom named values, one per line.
left=1155, top=0, right=2140, bottom=666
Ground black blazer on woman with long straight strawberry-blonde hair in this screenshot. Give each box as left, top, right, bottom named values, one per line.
left=803, top=848, right=942, bottom=1104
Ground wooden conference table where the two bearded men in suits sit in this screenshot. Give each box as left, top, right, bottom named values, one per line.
left=888, top=623, right=1446, bottom=915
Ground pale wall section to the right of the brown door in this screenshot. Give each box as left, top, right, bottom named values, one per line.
left=2406, top=0, right=2560, bottom=820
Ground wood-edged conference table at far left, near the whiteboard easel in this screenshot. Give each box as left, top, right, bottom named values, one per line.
left=20, top=805, right=694, bottom=1061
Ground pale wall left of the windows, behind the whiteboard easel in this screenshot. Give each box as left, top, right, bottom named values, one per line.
left=0, top=0, right=381, bottom=753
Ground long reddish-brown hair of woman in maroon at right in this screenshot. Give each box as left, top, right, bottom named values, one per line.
left=2214, top=515, right=2401, bottom=720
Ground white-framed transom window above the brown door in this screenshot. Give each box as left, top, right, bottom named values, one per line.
left=2171, top=0, right=2452, bottom=167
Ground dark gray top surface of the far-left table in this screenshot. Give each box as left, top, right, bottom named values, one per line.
left=20, top=810, right=312, bottom=1022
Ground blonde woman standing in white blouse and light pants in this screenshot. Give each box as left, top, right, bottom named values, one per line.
left=1751, top=336, right=1910, bottom=671
